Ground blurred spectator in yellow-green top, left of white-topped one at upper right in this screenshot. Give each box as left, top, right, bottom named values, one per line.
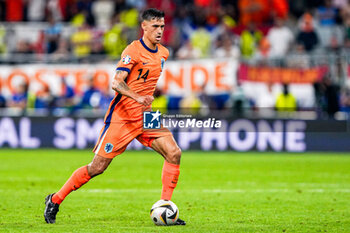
left=240, top=23, right=263, bottom=58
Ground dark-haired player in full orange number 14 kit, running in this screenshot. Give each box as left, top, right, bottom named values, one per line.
left=44, top=9, right=186, bottom=225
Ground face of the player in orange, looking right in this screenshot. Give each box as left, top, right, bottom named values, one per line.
left=142, top=18, right=165, bottom=44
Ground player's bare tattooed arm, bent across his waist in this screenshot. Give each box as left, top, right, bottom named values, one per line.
left=112, top=70, right=154, bottom=106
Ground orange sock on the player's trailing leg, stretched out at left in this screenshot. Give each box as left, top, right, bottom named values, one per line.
left=52, top=166, right=91, bottom=204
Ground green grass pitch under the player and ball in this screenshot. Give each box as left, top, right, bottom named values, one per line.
left=0, top=149, right=350, bottom=232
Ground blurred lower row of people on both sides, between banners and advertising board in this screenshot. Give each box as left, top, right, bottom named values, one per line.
left=0, top=74, right=350, bottom=119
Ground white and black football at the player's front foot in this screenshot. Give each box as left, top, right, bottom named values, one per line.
left=150, top=200, right=179, bottom=226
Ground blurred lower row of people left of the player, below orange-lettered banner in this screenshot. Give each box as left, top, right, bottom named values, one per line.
left=0, top=76, right=114, bottom=116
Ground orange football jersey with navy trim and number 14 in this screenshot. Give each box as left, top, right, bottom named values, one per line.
left=105, top=39, right=169, bottom=123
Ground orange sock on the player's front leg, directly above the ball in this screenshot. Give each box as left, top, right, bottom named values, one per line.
left=161, top=161, right=180, bottom=200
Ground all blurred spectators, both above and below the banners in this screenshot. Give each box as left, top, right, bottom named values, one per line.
left=0, top=0, right=350, bottom=117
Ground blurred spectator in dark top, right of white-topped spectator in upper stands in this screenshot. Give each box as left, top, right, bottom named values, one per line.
left=296, top=13, right=319, bottom=52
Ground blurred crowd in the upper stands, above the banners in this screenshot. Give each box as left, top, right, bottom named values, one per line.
left=0, top=0, right=350, bottom=62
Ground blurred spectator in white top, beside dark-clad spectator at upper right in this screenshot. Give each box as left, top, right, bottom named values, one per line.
left=267, top=17, right=294, bottom=59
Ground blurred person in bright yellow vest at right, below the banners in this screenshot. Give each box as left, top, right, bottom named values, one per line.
left=275, top=84, right=297, bottom=112
